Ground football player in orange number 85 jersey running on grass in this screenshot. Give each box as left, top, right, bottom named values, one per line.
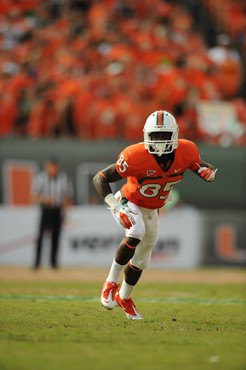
left=93, top=110, right=217, bottom=320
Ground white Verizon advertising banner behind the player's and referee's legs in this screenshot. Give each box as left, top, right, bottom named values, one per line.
left=0, top=206, right=203, bottom=268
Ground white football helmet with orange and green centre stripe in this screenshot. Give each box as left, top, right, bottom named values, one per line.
left=143, top=110, right=179, bottom=156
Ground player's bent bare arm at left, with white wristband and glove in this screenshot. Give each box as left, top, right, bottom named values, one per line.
left=93, top=163, right=135, bottom=229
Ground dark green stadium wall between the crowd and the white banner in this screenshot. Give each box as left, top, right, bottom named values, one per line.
left=0, top=139, right=246, bottom=210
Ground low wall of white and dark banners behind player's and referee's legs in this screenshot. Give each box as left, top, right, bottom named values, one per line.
left=0, top=206, right=246, bottom=269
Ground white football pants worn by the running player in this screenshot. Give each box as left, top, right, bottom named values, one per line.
left=112, top=191, right=159, bottom=270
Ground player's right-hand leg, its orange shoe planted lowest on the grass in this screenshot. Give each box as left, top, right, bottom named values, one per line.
left=115, top=211, right=159, bottom=320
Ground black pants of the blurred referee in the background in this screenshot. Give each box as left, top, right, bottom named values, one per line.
left=34, top=207, right=62, bottom=268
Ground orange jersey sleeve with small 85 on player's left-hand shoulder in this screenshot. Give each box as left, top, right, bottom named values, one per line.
left=116, top=147, right=136, bottom=178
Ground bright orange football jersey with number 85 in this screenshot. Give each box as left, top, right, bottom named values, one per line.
left=116, top=139, right=201, bottom=209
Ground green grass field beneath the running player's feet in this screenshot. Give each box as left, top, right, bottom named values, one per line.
left=0, top=282, right=246, bottom=370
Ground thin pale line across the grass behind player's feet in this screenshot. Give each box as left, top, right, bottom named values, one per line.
left=0, top=294, right=246, bottom=305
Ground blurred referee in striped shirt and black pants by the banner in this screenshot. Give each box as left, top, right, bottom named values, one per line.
left=32, top=158, right=73, bottom=269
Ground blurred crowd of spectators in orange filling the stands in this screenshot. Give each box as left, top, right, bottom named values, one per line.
left=0, top=0, right=246, bottom=145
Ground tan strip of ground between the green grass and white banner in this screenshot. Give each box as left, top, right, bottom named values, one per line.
left=0, top=266, right=246, bottom=284
